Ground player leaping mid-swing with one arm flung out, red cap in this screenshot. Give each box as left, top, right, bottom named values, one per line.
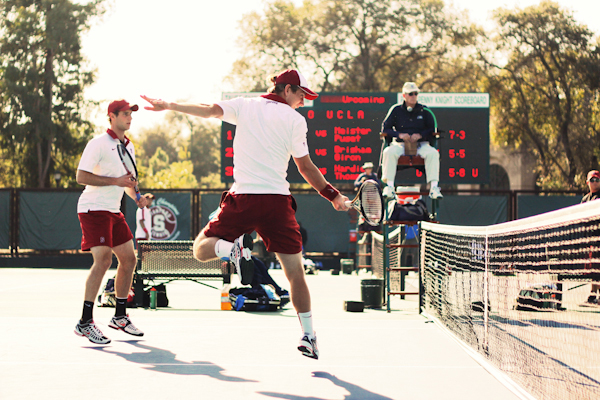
left=142, top=69, right=348, bottom=359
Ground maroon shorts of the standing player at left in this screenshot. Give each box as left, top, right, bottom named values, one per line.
left=77, top=211, right=133, bottom=251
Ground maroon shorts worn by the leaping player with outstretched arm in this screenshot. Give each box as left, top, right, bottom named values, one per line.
left=204, top=193, right=302, bottom=254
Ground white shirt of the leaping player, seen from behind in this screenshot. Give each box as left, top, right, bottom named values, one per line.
left=217, top=94, right=308, bottom=195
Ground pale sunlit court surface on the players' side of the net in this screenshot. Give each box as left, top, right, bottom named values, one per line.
left=0, top=268, right=519, bottom=400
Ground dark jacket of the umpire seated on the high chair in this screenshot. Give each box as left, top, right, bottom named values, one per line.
left=381, top=103, right=435, bottom=142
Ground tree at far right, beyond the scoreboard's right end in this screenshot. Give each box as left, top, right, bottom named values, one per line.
left=484, top=1, right=600, bottom=189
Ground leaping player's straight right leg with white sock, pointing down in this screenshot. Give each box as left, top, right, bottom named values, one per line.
left=276, top=252, right=319, bottom=359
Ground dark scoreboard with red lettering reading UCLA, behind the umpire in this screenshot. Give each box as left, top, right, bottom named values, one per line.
left=221, top=93, right=489, bottom=184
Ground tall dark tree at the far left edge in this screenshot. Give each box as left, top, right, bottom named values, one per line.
left=0, top=0, right=104, bottom=187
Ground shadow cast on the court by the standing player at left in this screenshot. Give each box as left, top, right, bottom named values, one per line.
left=85, top=340, right=256, bottom=382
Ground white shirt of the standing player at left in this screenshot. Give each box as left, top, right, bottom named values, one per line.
left=77, top=133, right=135, bottom=213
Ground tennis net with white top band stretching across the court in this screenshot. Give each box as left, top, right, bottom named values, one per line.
left=420, top=202, right=600, bottom=400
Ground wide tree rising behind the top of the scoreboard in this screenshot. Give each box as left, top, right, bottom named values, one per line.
left=229, top=0, right=478, bottom=91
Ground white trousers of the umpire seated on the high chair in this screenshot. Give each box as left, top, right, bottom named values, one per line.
left=381, top=140, right=440, bottom=186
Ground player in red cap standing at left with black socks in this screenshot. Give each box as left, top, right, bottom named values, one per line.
left=75, top=100, right=148, bottom=344
